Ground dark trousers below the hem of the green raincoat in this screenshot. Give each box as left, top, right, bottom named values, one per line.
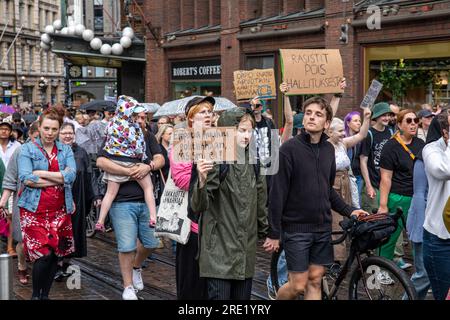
left=206, top=278, right=252, bottom=300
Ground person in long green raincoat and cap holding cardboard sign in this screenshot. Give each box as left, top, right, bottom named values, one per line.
left=191, top=108, right=268, bottom=300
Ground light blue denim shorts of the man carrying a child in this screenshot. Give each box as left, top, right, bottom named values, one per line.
left=109, top=202, right=159, bottom=252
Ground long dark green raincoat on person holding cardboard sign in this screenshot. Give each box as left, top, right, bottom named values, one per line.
left=191, top=158, right=268, bottom=280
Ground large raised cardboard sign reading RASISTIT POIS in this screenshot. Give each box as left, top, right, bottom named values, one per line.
left=280, top=49, right=344, bottom=95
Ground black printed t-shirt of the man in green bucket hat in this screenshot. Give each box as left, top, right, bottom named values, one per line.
left=361, top=127, right=394, bottom=189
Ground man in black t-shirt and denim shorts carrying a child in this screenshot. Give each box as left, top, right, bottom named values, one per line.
left=97, top=112, right=164, bottom=300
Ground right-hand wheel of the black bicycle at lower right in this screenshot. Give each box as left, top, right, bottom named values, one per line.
left=348, top=256, right=417, bottom=300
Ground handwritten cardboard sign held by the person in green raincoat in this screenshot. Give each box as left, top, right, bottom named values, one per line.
left=172, top=127, right=237, bottom=162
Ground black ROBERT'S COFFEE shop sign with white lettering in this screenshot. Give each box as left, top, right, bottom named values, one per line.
left=170, top=59, right=222, bottom=80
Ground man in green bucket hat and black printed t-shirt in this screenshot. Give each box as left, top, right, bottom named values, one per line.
left=360, top=102, right=394, bottom=212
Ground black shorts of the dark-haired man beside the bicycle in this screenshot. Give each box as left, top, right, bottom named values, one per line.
left=281, top=231, right=333, bottom=272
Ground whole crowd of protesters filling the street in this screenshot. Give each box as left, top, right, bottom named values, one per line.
left=0, top=79, right=450, bottom=300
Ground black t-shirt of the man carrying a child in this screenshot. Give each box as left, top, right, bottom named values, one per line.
left=98, top=132, right=161, bottom=202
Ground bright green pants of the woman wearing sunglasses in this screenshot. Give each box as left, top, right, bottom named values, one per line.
left=379, top=193, right=412, bottom=260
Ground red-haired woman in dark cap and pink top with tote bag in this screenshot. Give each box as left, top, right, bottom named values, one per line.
left=169, top=97, right=216, bottom=300
